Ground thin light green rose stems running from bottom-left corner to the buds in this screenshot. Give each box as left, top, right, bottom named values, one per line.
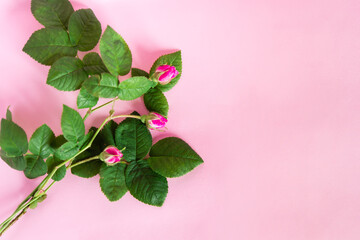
left=0, top=112, right=141, bottom=236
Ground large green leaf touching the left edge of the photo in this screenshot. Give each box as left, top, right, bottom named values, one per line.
left=0, top=119, right=28, bottom=157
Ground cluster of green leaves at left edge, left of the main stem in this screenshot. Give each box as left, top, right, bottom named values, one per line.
left=0, top=105, right=87, bottom=181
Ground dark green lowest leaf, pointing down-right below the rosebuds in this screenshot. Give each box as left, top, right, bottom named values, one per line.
left=125, top=160, right=168, bottom=207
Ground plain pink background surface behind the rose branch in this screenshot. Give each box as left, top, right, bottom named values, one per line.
left=0, top=0, right=360, bottom=240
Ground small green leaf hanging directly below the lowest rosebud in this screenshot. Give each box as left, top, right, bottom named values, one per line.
left=100, top=163, right=127, bottom=202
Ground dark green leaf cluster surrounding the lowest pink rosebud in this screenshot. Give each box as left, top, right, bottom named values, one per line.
left=71, top=112, right=203, bottom=206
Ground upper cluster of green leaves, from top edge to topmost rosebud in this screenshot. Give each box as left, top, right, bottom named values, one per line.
left=23, top=0, right=182, bottom=116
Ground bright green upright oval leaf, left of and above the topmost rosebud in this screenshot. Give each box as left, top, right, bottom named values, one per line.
left=100, top=26, right=132, bottom=76
